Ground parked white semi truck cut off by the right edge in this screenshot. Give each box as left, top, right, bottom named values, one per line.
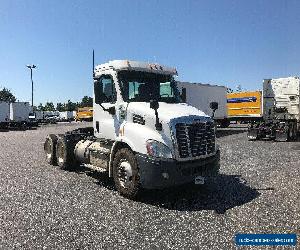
left=248, top=77, right=300, bottom=141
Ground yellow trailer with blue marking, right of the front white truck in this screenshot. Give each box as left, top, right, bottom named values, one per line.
left=227, top=91, right=263, bottom=121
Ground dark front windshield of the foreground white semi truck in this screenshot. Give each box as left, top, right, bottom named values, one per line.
left=118, top=71, right=181, bottom=103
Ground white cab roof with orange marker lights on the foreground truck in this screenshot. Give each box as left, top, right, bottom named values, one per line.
left=95, top=60, right=177, bottom=75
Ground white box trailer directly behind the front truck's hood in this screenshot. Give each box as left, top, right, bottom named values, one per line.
left=177, top=82, right=230, bottom=127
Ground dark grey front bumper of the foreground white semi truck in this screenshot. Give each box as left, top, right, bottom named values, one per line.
left=136, top=150, right=220, bottom=189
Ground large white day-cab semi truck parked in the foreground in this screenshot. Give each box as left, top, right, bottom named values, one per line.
left=44, top=60, right=220, bottom=198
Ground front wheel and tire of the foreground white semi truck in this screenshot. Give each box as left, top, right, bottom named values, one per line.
left=113, top=148, right=141, bottom=199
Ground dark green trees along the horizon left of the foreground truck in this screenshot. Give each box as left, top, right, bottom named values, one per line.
left=0, top=88, right=93, bottom=111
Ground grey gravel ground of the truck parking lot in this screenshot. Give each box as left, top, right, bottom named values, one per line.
left=0, top=123, right=300, bottom=249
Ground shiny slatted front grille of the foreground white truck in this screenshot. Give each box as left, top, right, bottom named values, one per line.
left=175, top=121, right=215, bottom=158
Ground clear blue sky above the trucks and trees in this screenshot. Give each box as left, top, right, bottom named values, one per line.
left=0, top=0, right=300, bottom=105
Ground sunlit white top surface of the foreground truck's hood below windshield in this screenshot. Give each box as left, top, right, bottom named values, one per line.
left=127, top=102, right=209, bottom=123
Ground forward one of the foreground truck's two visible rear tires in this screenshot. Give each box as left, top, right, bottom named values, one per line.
left=56, top=136, right=78, bottom=170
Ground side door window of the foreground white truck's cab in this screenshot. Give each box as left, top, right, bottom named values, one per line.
left=95, top=75, right=117, bottom=103
